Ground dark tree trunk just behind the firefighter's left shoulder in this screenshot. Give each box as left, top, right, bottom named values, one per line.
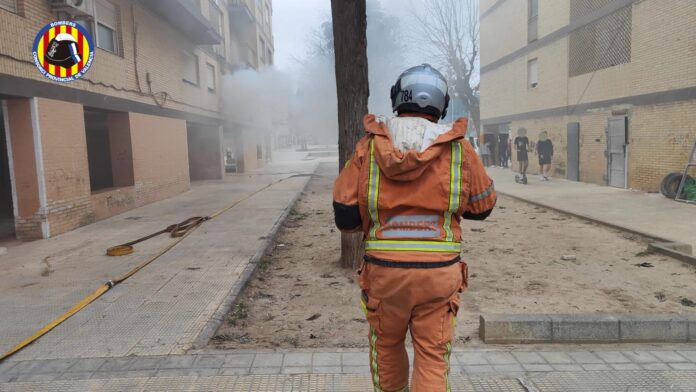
left=331, top=0, right=370, bottom=268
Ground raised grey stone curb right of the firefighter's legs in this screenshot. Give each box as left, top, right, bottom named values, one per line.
left=479, top=312, right=696, bottom=344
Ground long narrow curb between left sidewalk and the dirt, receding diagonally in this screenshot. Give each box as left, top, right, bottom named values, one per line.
left=192, top=165, right=319, bottom=352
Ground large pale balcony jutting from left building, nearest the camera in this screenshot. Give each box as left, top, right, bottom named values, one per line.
left=140, top=0, right=222, bottom=45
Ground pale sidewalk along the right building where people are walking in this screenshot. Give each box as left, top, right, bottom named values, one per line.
left=487, top=168, right=696, bottom=251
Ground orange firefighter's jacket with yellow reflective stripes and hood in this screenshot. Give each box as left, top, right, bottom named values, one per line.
left=333, top=115, right=497, bottom=268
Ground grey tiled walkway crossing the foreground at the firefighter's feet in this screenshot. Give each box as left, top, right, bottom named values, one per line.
left=0, top=345, right=696, bottom=392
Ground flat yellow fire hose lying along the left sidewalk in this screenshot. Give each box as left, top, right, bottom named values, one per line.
left=0, top=174, right=302, bottom=363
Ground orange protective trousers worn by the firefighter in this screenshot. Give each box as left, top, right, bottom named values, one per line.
left=358, top=262, right=467, bottom=392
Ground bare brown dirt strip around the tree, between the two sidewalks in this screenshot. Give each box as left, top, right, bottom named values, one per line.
left=211, top=164, right=696, bottom=348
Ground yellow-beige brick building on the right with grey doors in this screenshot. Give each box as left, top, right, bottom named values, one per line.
left=481, top=0, right=696, bottom=192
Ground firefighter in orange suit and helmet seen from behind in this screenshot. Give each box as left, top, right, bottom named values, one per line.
left=333, top=64, right=496, bottom=392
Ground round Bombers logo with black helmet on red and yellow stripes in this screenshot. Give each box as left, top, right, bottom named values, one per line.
left=33, top=20, right=94, bottom=82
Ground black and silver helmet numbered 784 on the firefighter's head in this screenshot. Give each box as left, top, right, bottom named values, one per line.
left=391, top=64, right=450, bottom=119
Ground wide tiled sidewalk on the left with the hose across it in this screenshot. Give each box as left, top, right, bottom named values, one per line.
left=0, top=157, right=316, bottom=361
